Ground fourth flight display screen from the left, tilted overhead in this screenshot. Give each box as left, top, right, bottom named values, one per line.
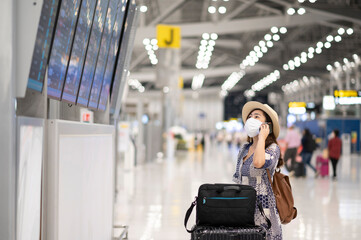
left=77, top=0, right=109, bottom=107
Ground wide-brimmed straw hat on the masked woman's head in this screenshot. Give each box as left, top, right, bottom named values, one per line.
left=242, top=101, right=280, bottom=138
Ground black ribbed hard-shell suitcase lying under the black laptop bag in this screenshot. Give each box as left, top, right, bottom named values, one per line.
left=191, top=226, right=266, bottom=240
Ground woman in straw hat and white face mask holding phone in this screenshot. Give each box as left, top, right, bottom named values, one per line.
left=233, top=101, right=283, bottom=240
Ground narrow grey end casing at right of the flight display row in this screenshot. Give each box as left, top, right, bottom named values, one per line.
left=110, top=1, right=136, bottom=113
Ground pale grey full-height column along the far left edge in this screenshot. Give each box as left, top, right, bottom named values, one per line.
left=0, top=0, right=16, bottom=240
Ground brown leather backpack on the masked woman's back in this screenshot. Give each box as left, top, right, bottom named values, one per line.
left=267, top=169, right=297, bottom=224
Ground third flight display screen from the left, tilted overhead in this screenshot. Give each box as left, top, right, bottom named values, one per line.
left=62, top=0, right=96, bottom=103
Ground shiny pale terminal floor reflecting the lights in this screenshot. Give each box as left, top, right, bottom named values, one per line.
left=114, top=146, right=361, bottom=240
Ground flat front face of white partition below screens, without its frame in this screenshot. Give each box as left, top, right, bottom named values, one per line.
left=59, top=135, right=113, bottom=240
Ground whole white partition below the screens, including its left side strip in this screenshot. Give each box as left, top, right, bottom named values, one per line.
left=44, top=120, right=115, bottom=240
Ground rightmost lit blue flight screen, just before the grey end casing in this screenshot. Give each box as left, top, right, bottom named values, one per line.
left=98, top=0, right=128, bottom=110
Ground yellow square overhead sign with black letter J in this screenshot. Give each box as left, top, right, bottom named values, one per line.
left=157, top=24, right=181, bottom=48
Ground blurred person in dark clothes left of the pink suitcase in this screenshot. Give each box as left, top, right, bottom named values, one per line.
left=301, top=128, right=319, bottom=177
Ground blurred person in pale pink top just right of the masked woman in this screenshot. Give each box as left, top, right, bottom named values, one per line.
left=283, top=125, right=301, bottom=176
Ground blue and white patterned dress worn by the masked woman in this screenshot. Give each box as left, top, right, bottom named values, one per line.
left=233, top=143, right=282, bottom=240
